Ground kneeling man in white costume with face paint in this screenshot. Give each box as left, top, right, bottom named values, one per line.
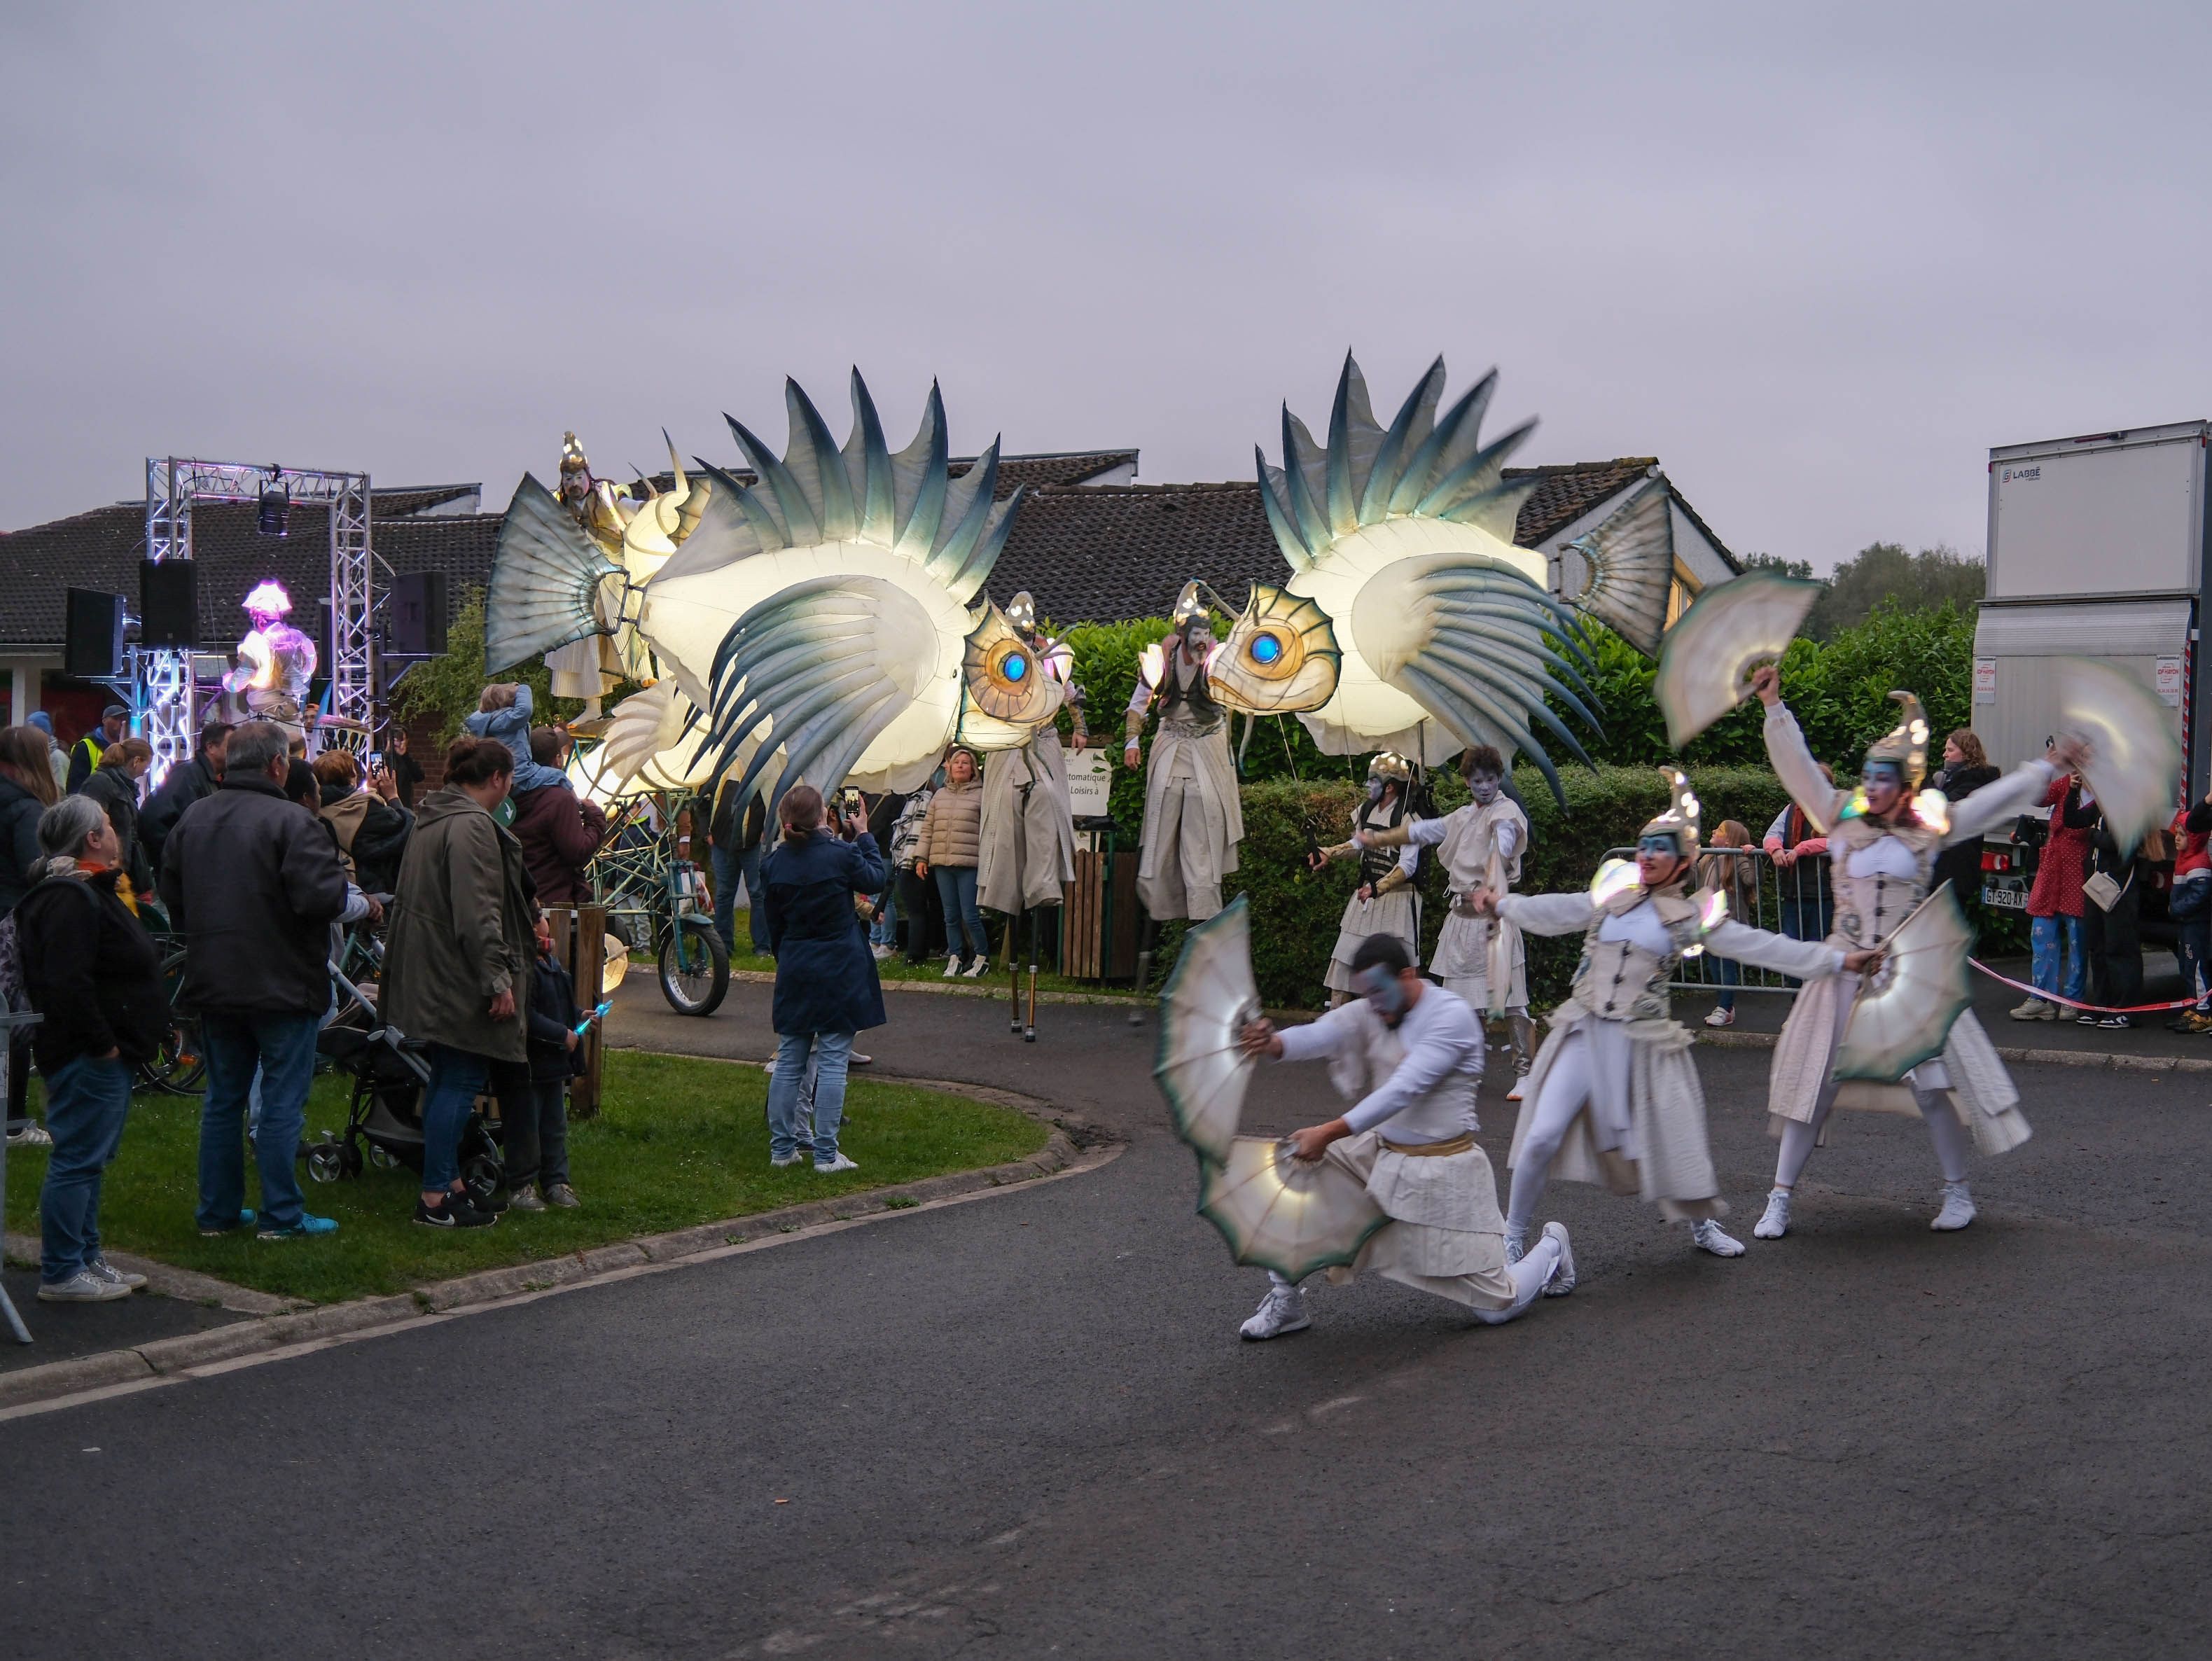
left=1243, top=933, right=1575, bottom=1338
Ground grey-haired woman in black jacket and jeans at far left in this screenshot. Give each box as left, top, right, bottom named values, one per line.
left=13, top=796, right=168, bottom=1302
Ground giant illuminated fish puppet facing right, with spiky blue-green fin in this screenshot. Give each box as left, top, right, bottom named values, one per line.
left=485, top=369, right=1069, bottom=798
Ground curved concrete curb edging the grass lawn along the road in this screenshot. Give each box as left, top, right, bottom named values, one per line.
left=0, top=1079, right=1122, bottom=1420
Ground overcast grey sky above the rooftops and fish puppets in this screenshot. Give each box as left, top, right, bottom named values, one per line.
left=0, top=0, right=2212, bottom=569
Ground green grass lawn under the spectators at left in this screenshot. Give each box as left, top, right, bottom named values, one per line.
left=6, top=1050, right=1048, bottom=1302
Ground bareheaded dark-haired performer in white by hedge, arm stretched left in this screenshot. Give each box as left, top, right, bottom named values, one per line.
left=1344, top=743, right=1535, bottom=1101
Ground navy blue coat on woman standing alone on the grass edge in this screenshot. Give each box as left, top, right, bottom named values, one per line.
left=761, top=829, right=885, bottom=1037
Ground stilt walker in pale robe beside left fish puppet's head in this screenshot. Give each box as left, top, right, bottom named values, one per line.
left=975, top=590, right=1090, bottom=1044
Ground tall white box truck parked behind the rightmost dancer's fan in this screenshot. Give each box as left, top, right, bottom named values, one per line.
left=1973, top=420, right=2212, bottom=913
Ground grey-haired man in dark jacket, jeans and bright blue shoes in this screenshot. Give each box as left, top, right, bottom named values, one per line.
left=162, top=721, right=345, bottom=1239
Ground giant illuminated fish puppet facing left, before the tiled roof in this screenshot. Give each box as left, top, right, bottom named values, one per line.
left=1208, top=354, right=1674, bottom=794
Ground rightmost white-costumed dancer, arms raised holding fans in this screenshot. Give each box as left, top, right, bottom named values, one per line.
left=1752, top=664, right=2088, bottom=1241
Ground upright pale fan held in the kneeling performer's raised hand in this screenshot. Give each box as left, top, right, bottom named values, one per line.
left=1153, top=894, right=1261, bottom=1166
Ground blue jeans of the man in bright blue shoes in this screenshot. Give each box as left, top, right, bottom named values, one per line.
left=199, top=1015, right=323, bottom=1228
